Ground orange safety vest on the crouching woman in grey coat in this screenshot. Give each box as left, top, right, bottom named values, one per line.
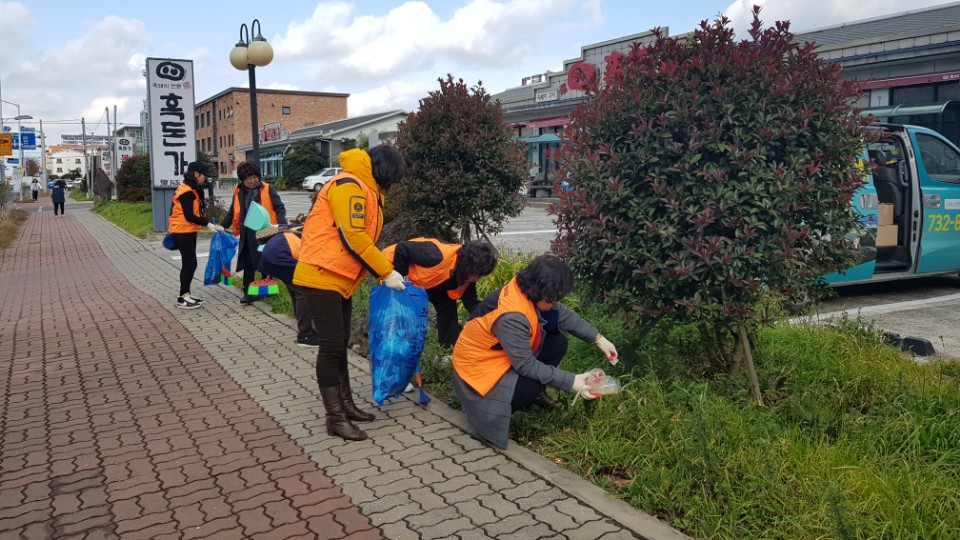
left=453, top=278, right=543, bottom=396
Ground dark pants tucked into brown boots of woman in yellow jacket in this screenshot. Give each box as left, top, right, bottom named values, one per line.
left=301, top=287, right=353, bottom=388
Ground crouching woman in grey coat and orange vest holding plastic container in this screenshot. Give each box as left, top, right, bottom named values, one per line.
left=451, top=254, right=617, bottom=448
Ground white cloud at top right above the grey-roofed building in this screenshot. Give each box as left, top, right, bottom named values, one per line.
left=724, top=0, right=944, bottom=36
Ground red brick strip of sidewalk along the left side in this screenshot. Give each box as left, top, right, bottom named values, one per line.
left=0, top=213, right=381, bottom=539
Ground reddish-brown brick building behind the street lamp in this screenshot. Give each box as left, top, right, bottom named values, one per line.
left=194, top=87, right=350, bottom=177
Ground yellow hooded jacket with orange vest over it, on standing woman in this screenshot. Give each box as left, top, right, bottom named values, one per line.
left=293, top=148, right=393, bottom=298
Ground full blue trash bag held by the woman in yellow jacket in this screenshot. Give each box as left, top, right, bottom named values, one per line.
left=368, top=281, right=428, bottom=405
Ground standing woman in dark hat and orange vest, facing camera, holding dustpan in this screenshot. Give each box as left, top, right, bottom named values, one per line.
left=223, top=161, right=287, bottom=305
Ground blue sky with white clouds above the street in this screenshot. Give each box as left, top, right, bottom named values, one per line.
left=0, top=0, right=948, bottom=152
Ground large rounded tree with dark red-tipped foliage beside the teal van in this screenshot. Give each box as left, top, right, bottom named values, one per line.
left=554, top=7, right=865, bottom=399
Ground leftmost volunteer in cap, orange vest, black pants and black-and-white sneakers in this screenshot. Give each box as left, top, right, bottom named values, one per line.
left=168, top=161, right=223, bottom=309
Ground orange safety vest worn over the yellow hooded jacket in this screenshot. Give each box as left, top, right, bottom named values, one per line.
left=300, top=173, right=383, bottom=280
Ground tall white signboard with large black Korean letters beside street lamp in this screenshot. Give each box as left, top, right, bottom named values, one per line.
left=147, top=58, right=197, bottom=189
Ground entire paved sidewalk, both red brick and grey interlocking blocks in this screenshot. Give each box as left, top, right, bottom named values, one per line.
left=0, top=211, right=652, bottom=539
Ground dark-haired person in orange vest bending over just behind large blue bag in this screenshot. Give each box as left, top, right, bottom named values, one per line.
left=383, top=238, right=497, bottom=349
